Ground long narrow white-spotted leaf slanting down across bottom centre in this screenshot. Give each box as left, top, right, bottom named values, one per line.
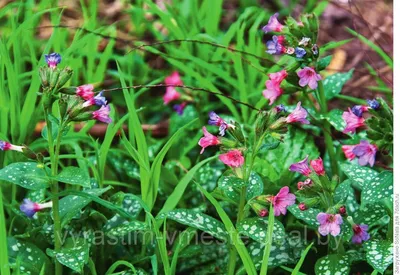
left=158, top=209, right=228, bottom=240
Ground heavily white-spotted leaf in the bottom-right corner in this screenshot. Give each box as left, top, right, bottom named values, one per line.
left=363, top=240, right=393, bottom=274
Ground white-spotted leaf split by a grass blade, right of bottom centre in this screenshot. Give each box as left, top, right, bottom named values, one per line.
left=237, top=218, right=286, bottom=246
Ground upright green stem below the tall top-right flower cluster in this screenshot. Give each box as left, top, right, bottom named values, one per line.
left=318, top=81, right=339, bottom=175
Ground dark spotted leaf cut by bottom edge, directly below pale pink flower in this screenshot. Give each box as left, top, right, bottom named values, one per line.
left=314, top=254, right=350, bottom=275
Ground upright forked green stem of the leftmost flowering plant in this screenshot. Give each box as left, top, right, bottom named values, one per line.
left=43, top=106, right=63, bottom=275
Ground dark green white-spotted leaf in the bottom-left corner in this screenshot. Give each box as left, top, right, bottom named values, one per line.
left=7, top=237, right=51, bottom=274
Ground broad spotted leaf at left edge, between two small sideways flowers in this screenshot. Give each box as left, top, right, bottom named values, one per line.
left=0, top=162, right=48, bottom=190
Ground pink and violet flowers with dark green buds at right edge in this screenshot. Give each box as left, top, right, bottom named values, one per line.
left=342, top=98, right=393, bottom=167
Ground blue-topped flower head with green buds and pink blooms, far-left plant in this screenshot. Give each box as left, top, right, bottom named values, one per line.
left=39, top=53, right=112, bottom=123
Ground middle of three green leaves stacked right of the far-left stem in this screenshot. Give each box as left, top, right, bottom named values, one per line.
left=56, top=188, right=108, bottom=226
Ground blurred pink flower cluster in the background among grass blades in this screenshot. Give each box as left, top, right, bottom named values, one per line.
left=163, top=71, right=193, bottom=115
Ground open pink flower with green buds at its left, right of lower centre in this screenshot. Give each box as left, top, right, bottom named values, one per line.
left=249, top=186, right=296, bottom=217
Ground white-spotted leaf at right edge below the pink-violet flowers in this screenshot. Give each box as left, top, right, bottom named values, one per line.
left=361, top=171, right=393, bottom=207
